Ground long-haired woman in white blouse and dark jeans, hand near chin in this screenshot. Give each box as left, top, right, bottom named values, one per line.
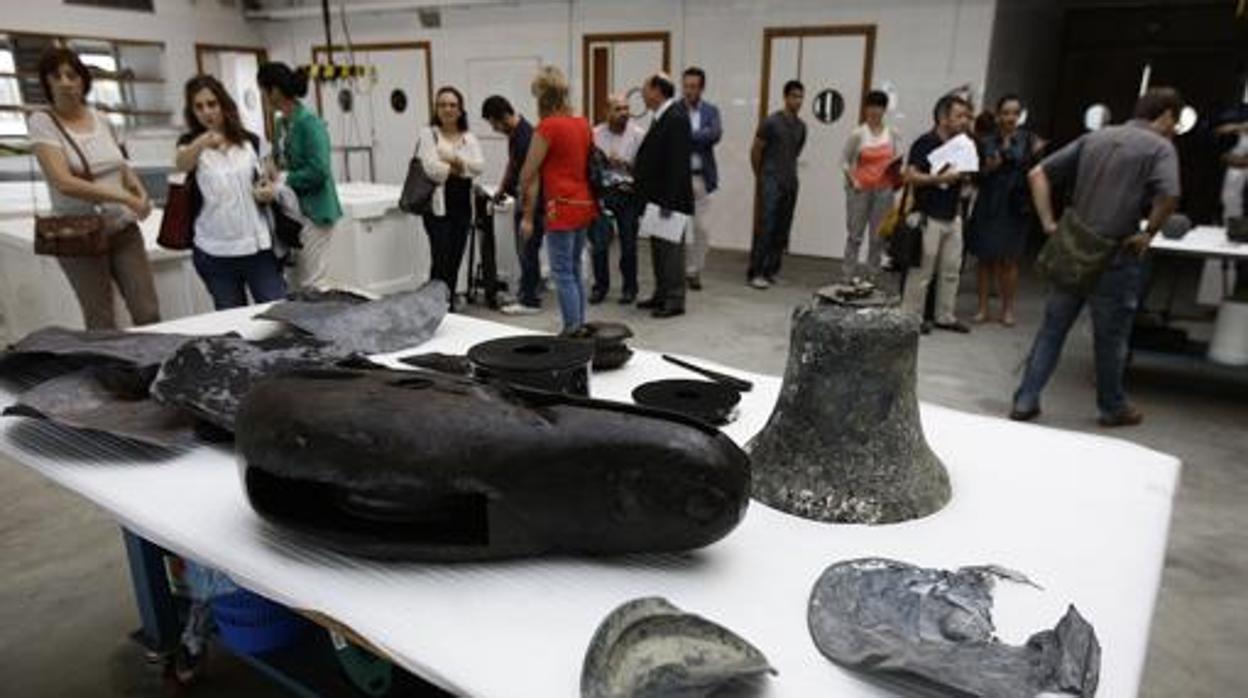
left=176, top=75, right=286, bottom=310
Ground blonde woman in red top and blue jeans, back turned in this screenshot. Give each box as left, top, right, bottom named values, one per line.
left=520, top=66, right=598, bottom=335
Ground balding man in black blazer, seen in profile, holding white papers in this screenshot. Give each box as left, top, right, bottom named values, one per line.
left=633, top=72, right=694, bottom=318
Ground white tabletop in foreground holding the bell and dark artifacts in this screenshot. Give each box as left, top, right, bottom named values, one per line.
left=0, top=308, right=1179, bottom=698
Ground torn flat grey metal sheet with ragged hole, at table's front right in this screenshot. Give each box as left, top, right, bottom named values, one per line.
left=807, top=558, right=1101, bottom=698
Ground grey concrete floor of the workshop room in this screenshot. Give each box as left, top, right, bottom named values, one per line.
left=0, top=245, right=1248, bottom=698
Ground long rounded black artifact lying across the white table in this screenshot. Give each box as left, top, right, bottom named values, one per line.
left=235, top=370, right=750, bottom=561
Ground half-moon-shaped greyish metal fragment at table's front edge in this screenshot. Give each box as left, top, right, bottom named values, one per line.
left=580, top=597, right=776, bottom=698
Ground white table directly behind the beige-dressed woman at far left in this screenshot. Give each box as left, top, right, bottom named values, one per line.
left=0, top=210, right=212, bottom=341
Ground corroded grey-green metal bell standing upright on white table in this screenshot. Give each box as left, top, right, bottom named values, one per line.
left=749, top=287, right=950, bottom=523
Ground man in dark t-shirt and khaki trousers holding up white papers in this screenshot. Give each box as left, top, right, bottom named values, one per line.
left=901, top=95, right=971, bottom=333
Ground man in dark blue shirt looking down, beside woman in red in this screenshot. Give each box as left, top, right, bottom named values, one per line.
left=480, top=95, right=545, bottom=315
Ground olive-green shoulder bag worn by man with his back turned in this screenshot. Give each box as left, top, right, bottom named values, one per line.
left=1036, top=206, right=1121, bottom=295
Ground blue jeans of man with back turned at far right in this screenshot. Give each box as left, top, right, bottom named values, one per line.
left=1013, top=252, right=1143, bottom=417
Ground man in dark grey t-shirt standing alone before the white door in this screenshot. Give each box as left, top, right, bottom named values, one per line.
left=746, top=80, right=806, bottom=290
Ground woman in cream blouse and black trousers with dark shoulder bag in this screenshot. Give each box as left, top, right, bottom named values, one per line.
left=416, top=87, right=485, bottom=303
